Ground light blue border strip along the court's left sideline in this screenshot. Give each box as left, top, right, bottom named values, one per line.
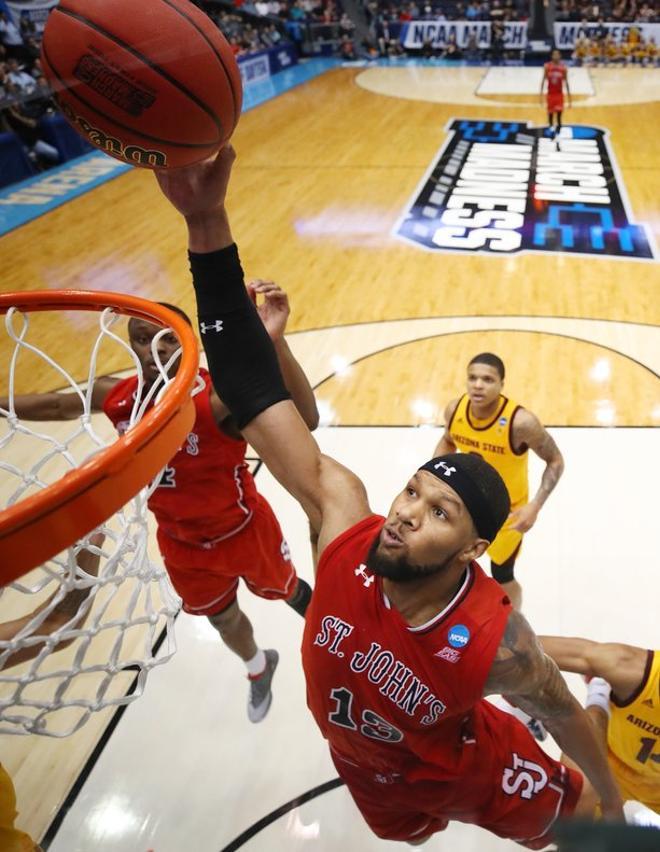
left=0, top=58, right=341, bottom=236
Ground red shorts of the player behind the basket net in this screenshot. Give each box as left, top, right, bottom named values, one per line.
left=157, top=494, right=296, bottom=615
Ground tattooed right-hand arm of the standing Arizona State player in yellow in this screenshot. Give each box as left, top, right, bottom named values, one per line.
left=509, top=408, right=564, bottom=532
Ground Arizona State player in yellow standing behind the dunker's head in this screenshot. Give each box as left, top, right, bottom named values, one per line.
left=434, top=352, right=564, bottom=609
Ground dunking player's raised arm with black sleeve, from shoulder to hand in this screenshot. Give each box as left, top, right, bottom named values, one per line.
left=156, top=146, right=370, bottom=551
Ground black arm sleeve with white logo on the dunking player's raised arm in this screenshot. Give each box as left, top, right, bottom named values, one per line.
left=188, top=244, right=290, bottom=429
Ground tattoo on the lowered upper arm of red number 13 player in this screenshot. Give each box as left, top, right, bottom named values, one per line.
left=485, top=612, right=575, bottom=728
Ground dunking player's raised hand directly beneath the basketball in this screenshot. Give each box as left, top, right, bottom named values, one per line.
left=154, top=145, right=236, bottom=219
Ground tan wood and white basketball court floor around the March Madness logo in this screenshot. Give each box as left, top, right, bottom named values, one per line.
left=0, top=67, right=660, bottom=852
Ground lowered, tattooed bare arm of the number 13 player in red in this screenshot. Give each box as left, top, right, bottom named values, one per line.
left=485, top=611, right=623, bottom=819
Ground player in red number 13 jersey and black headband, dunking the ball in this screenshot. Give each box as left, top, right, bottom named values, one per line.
left=157, top=148, right=623, bottom=849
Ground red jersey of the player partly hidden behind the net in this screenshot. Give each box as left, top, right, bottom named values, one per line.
left=103, top=369, right=257, bottom=545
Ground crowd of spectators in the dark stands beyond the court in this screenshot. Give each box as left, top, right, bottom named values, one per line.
left=0, top=0, right=660, bottom=181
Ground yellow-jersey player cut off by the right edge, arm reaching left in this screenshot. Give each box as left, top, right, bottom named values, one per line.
left=539, top=636, right=660, bottom=814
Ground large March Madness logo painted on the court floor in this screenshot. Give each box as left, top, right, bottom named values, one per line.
left=395, top=119, right=654, bottom=260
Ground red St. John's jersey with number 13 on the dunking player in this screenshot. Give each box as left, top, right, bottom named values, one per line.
left=302, top=515, right=511, bottom=781
